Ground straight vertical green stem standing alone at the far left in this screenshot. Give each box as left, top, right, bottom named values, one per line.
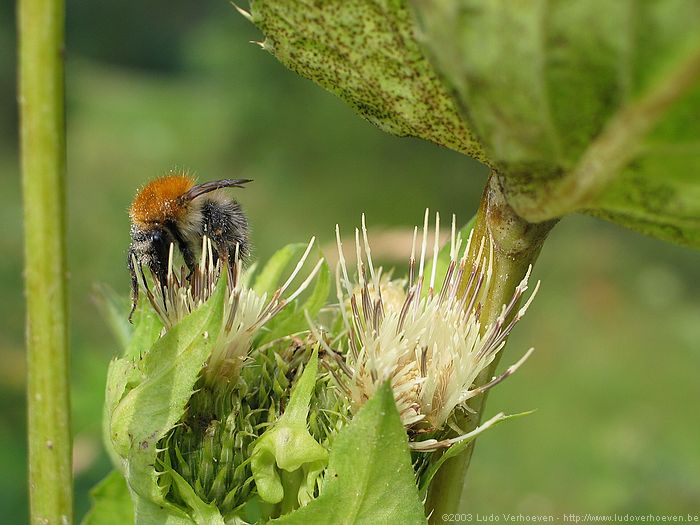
left=18, top=0, right=73, bottom=525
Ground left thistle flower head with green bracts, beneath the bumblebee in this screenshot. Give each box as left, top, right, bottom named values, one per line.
left=114, top=238, right=330, bottom=522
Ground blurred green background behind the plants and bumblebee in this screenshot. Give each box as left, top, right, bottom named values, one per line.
left=0, top=0, right=700, bottom=523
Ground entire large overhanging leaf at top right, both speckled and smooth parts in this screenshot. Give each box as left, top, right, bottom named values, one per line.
left=245, top=0, right=700, bottom=247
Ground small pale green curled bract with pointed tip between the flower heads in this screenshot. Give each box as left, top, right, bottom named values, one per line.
left=251, top=352, right=328, bottom=506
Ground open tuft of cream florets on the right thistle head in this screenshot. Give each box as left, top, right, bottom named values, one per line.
left=328, top=211, right=539, bottom=449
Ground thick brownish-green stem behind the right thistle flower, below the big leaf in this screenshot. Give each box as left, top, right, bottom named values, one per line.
left=426, top=174, right=556, bottom=524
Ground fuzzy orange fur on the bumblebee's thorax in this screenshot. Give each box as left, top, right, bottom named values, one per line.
left=129, top=175, right=195, bottom=225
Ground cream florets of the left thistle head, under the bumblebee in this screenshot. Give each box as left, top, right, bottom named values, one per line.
left=134, top=237, right=323, bottom=384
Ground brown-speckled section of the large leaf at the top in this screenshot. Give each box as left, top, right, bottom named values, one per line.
left=249, top=0, right=485, bottom=160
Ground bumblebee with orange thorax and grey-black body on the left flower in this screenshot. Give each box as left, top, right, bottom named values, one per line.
left=128, top=173, right=252, bottom=320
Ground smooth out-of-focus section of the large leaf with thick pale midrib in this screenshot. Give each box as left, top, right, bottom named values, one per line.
left=412, top=0, right=700, bottom=247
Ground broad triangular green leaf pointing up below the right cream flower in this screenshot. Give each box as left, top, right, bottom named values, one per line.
left=272, top=384, right=427, bottom=525
